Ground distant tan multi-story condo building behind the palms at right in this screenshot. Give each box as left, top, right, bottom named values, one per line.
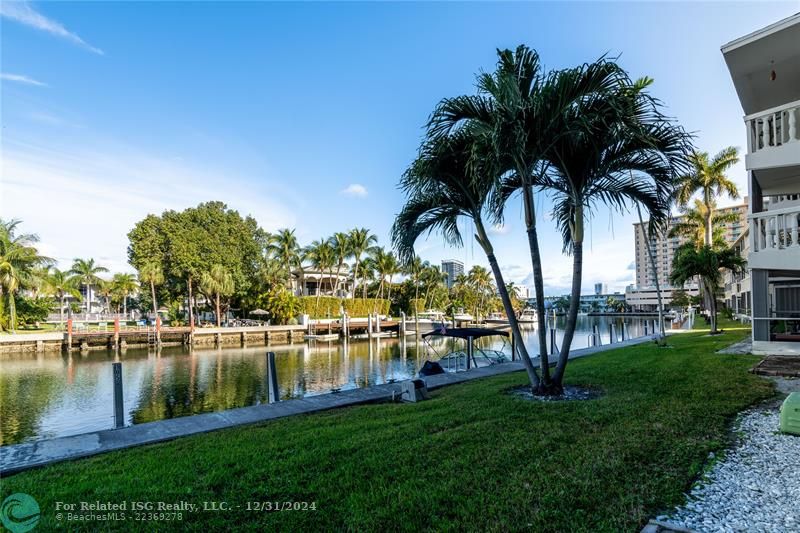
left=633, top=198, right=747, bottom=289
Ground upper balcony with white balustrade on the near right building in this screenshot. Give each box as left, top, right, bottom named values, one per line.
left=744, top=100, right=800, bottom=170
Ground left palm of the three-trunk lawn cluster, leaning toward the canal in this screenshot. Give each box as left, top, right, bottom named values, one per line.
left=392, top=127, right=540, bottom=390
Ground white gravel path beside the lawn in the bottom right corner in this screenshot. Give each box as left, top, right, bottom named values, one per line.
left=658, top=407, right=800, bottom=533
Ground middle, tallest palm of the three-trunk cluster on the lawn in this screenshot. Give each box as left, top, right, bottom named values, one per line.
left=429, top=45, right=620, bottom=384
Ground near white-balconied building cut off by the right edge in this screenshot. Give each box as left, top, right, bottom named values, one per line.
left=722, top=13, right=800, bottom=354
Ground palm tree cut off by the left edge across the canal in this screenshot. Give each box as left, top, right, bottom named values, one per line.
left=0, top=219, right=53, bottom=331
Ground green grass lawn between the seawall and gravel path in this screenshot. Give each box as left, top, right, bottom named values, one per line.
left=2, top=328, right=773, bottom=531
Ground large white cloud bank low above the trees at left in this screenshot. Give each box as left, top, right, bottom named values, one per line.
left=0, top=140, right=302, bottom=271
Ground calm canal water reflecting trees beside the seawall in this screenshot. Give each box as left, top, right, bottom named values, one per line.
left=0, top=316, right=656, bottom=445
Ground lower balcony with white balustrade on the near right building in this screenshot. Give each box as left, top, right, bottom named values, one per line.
left=748, top=206, right=800, bottom=270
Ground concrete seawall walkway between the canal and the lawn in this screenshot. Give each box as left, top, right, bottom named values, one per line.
left=0, top=336, right=652, bottom=476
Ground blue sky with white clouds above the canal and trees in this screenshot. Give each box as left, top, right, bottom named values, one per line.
left=0, top=1, right=800, bottom=294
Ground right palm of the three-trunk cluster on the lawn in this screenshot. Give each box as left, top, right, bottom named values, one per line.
left=543, top=74, right=691, bottom=390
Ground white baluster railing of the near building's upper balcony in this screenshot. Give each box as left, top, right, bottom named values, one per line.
left=744, top=100, right=800, bottom=154
